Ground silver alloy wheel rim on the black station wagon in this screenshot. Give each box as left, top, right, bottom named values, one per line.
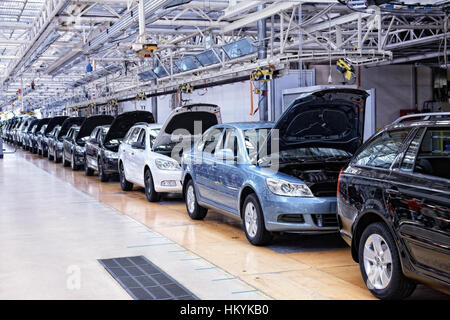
left=363, top=234, right=392, bottom=290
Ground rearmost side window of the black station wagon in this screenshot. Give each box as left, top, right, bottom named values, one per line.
left=353, top=130, right=409, bottom=169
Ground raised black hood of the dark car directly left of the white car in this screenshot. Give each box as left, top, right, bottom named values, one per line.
left=103, top=111, right=155, bottom=145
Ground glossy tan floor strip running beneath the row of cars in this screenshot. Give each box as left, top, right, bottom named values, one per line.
left=4, top=145, right=448, bottom=299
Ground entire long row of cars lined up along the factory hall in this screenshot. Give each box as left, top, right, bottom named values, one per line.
left=3, top=89, right=450, bottom=299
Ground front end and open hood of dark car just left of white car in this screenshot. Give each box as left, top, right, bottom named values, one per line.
left=97, top=111, right=155, bottom=182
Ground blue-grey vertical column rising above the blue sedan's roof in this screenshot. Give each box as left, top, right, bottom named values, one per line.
left=258, top=4, right=269, bottom=121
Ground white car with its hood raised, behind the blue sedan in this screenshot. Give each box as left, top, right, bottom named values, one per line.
left=119, top=104, right=222, bottom=202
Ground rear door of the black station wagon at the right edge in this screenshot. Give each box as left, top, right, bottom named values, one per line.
left=388, top=127, right=450, bottom=282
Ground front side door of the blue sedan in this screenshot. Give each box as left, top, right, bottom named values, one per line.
left=215, top=128, right=244, bottom=214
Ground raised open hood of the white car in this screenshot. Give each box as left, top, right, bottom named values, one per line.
left=153, top=104, right=222, bottom=150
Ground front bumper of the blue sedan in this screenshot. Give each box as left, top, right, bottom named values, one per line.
left=261, top=193, right=339, bottom=234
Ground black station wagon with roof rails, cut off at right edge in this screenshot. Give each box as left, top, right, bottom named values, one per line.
left=337, top=113, right=450, bottom=299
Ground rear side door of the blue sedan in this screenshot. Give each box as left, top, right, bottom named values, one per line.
left=193, top=127, right=224, bottom=203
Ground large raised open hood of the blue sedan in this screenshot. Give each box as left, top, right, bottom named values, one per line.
left=263, top=88, right=368, bottom=154
